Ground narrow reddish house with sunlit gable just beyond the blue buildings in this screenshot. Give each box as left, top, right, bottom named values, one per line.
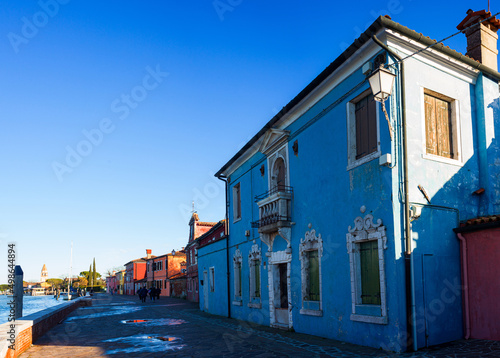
left=185, top=213, right=217, bottom=302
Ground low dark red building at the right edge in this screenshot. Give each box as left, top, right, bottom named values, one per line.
left=454, top=215, right=500, bottom=341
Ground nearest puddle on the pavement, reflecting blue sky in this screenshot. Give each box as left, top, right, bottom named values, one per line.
left=104, top=334, right=185, bottom=354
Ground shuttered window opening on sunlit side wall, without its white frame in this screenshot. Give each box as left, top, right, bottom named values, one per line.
left=424, top=90, right=458, bottom=159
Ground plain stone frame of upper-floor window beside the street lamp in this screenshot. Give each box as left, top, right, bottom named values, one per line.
left=346, top=89, right=382, bottom=171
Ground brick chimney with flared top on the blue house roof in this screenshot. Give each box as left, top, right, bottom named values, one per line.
left=457, top=9, right=500, bottom=71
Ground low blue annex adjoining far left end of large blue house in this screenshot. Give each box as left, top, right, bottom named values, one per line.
left=198, top=220, right=228, bottom=316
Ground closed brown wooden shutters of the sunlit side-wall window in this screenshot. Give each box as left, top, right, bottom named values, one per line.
left=424, top=94, right=454, bottom=158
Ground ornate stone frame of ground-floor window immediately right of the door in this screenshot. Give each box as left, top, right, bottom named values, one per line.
left=299, top=224, right=323, bottom=317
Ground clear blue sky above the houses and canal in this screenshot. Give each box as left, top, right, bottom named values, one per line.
left=0, top=0, right=484, bottom=282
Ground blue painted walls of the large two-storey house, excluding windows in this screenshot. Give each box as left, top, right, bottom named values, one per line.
left=217, top=35, right=500, bottom=351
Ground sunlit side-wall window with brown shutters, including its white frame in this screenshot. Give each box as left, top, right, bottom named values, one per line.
left=421, top=88, right=462, bottom=165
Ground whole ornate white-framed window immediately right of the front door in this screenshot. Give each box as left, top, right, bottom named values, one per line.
left=299, top=224, right=323, bottom=316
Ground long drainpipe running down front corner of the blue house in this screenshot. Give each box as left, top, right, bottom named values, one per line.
left=372, top=35, right=417, bottom=351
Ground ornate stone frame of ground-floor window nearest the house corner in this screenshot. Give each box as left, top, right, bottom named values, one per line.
left=346, top=211, right=388, bottom=324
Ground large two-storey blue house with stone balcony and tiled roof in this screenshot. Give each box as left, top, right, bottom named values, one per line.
left=208, top=11, right=500, bottom=351
